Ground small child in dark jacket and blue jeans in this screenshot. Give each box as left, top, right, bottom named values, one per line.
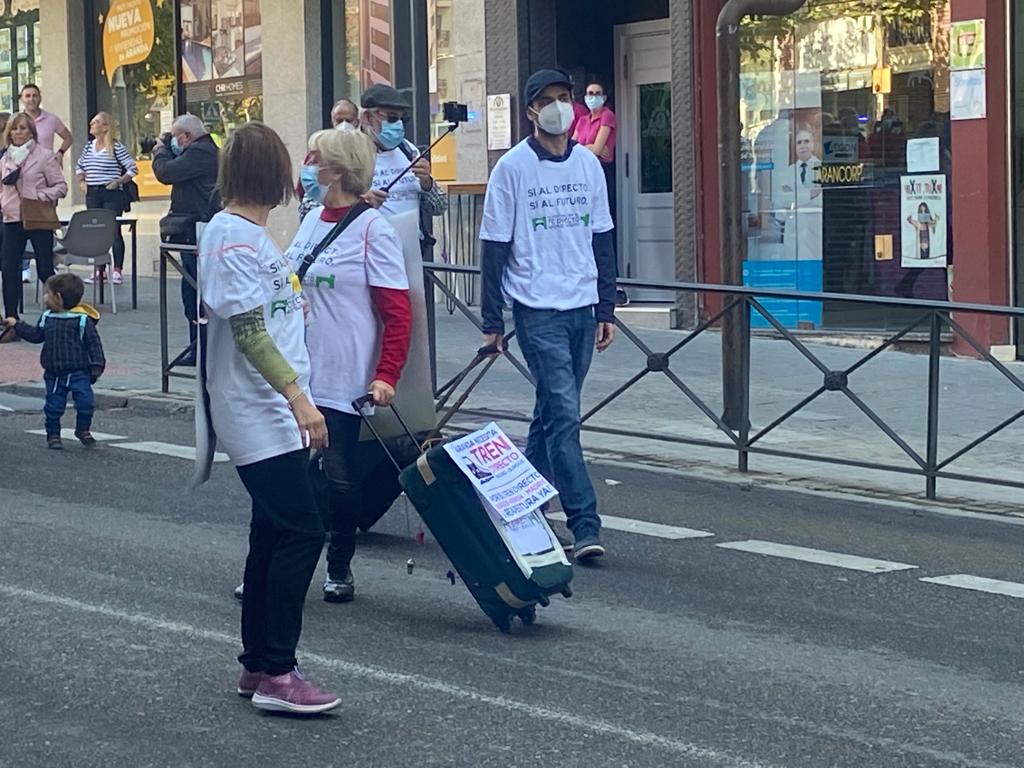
left=4, top=272, right=106, bottom=451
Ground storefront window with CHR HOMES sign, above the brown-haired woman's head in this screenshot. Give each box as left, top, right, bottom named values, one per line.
left=179, top=0, right=263, bottom=143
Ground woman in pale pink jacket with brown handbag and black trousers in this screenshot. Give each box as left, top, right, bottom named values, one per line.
left=0, top=113, right=68, bottom=317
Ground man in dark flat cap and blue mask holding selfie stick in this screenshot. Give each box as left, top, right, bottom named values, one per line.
left=360, top=84, right=447, bottom=227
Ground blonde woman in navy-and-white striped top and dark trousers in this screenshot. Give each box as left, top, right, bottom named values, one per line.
left=75, top=112, right=138, bottom=286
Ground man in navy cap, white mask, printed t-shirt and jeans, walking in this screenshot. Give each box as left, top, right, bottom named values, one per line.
left=480, top=70, right=615, bottom=561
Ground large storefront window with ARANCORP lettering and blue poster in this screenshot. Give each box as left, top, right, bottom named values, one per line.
left=740, top=0, right=952, bottom=329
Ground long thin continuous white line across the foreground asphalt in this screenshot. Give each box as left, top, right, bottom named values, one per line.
left=0, top=585, right=771, bottom=768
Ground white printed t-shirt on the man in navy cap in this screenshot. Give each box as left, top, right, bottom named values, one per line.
left=480, top=139, right=614, bottom=310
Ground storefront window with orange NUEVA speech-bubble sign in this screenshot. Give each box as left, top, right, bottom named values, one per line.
left=88, top=0, right=175, bottom=198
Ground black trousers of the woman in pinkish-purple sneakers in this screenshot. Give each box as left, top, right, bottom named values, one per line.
left=238, top=451, right=324, bottom=675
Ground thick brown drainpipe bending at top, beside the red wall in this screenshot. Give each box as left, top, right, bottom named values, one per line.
left=715, top=0, right=806, bottom=433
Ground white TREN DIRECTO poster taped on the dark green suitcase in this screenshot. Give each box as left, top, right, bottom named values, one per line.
left=444, top=422, right=557, bottom=523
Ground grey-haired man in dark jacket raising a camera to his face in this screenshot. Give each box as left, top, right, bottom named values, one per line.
left=153, top=114, right=220, bottom=365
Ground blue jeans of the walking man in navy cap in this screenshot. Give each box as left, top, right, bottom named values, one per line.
left=512, top=304, right=601, bottom=542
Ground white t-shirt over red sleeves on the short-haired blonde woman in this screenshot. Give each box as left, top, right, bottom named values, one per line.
left=288, top=206, right=409, bottom=414
